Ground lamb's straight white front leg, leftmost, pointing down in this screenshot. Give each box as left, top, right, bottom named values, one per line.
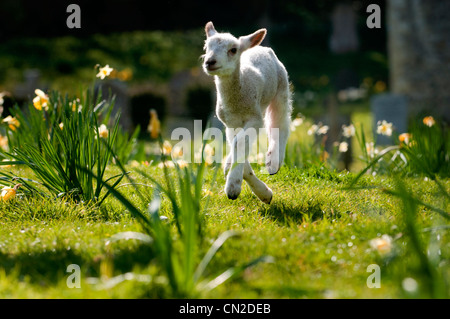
left=225, top=119, right=262, bottom=200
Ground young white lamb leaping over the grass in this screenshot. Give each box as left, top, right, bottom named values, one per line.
left=202, top=22, right=291, bottom=204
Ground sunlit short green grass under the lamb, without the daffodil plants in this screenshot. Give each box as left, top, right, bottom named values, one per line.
left=0, top=166, right=450, bottom=298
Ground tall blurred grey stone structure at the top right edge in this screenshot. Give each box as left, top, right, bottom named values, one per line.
left=387, top=0, right=450, bottom=122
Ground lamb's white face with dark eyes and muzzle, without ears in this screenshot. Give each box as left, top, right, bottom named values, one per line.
left=203, top=33, right=241, bottom=76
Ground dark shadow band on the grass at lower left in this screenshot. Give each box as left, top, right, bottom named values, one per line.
left=0, top=244, right=154, bottom=285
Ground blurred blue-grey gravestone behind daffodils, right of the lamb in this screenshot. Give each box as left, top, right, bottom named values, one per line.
left=370, top=93, right=408, bottom=145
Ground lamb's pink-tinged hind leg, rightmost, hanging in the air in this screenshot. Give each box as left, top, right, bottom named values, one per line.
left=265, top=88, right=291, bottom=175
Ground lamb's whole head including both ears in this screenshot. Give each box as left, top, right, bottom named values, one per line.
left=203, top=22, right=267, bottom=77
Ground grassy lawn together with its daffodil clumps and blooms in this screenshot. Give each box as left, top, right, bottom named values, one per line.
left=0, top=68, right=444, bottom=298
